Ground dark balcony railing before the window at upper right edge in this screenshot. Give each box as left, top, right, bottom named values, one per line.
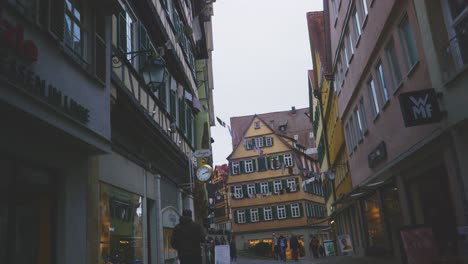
left=442, top=16, right=468, bottom=81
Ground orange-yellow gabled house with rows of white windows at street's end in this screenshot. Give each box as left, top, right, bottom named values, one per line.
left=228, top=107, right=328, bottom=254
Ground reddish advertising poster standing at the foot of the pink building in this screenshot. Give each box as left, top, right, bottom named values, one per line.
left=400, top=226, right=437, bottom=264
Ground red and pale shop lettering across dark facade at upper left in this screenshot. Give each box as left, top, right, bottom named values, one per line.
left=0, top=17, right=89, bottom=124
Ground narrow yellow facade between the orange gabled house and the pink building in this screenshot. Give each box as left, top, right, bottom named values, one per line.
left=307, top=11, right=361, bottom=256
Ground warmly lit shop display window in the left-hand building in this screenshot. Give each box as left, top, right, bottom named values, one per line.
left=99, top=183, right=144, bottom=264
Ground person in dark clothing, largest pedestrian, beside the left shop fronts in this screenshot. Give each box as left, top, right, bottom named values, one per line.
left=171, top=209, right=205, bottom=264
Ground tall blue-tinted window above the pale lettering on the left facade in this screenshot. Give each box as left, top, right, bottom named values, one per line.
left=63, top=0, right=85, bottom=59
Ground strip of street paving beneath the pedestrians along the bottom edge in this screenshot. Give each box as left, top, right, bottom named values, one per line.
left=234, top=256, right=400, bottom=264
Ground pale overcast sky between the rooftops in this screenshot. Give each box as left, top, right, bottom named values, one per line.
left=211, top=0, right=323, bottom=165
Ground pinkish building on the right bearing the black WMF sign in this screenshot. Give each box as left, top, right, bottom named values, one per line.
left=324, top=0, right=466, bottom=259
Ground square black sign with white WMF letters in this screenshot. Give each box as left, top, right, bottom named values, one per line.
left=399, top=89, right=442, bottom=127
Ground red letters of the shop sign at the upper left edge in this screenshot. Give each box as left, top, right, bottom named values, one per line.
left=0, top=17, right=38, bottom=62
